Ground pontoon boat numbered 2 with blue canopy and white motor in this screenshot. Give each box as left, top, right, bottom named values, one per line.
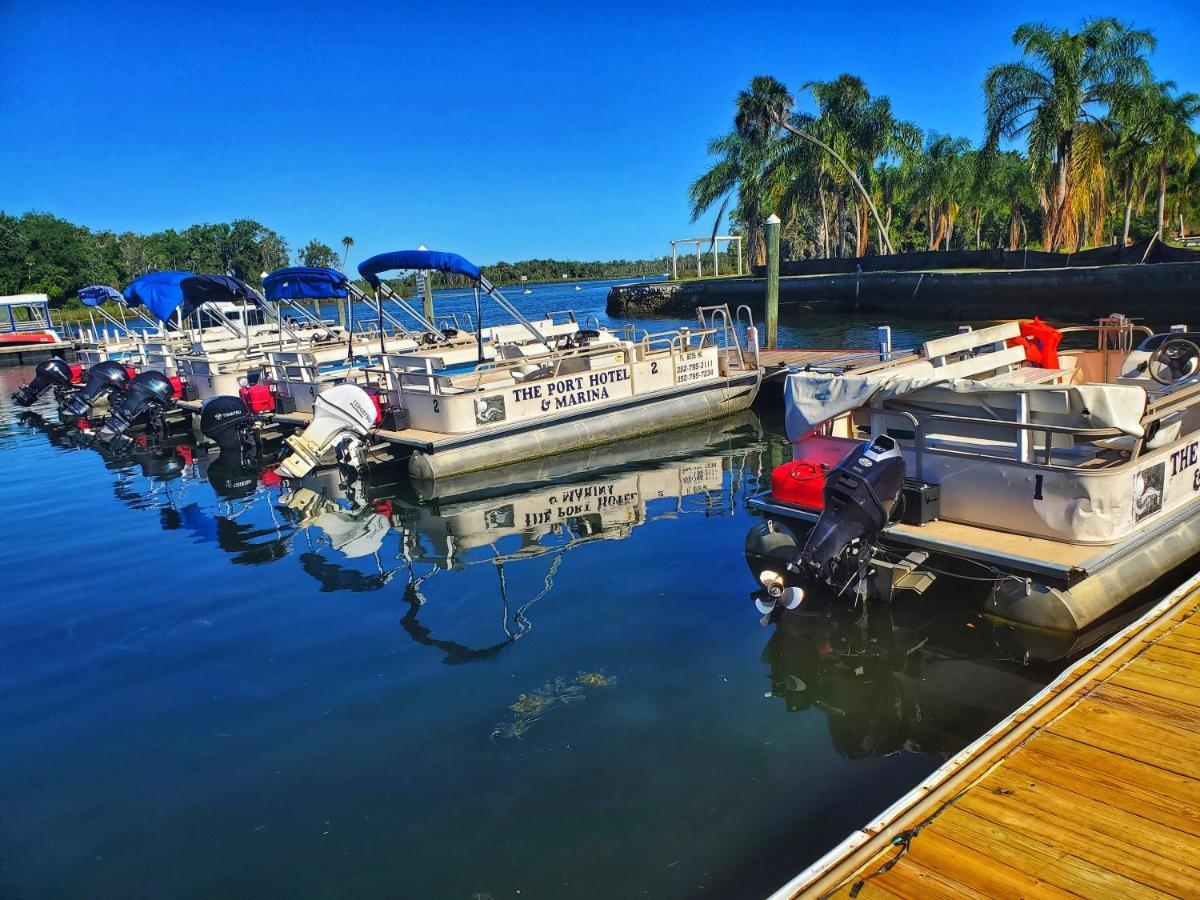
left=280, top=251, right=762, bottom=487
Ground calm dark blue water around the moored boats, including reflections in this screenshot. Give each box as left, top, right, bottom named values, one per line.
left=0, top=292, right=1099, bottom=899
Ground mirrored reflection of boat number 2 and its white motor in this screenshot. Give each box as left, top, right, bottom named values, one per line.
left=281, top=413, right=763, bottom=664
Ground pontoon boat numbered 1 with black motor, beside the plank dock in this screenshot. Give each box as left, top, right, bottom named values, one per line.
left=748, top=316, right=1200, bottom=630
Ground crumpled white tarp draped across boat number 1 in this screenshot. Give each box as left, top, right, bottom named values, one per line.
left=784, top=366, right=1146, bottom=440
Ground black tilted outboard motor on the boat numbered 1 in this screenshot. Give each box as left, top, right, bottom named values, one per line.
left=758, top=434, right=905, bottom=614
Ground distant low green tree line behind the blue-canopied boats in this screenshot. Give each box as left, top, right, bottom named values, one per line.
left=0, top=211, right=670, bottom=306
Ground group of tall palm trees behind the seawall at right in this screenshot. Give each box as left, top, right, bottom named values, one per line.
left=689, top=18, right=1200, bottom=264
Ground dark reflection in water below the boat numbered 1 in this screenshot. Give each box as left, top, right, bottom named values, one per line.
left=762, top=584, right=1141, bottom=760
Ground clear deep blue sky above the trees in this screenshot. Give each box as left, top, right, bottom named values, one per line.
left=0, top=0, right=1200, bottom=263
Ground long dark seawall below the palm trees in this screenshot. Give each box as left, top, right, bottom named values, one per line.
left=607, top=263, right=1200, bottom=329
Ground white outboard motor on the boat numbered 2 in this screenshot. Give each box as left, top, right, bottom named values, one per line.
left=278, top=384, right=380, bottom=478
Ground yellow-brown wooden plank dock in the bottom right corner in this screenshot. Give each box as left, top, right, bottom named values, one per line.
left=775, top=575, right=1200, bottom=898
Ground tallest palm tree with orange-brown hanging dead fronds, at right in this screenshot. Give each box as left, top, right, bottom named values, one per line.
left=983, top=18, right=1156, bottom=250
